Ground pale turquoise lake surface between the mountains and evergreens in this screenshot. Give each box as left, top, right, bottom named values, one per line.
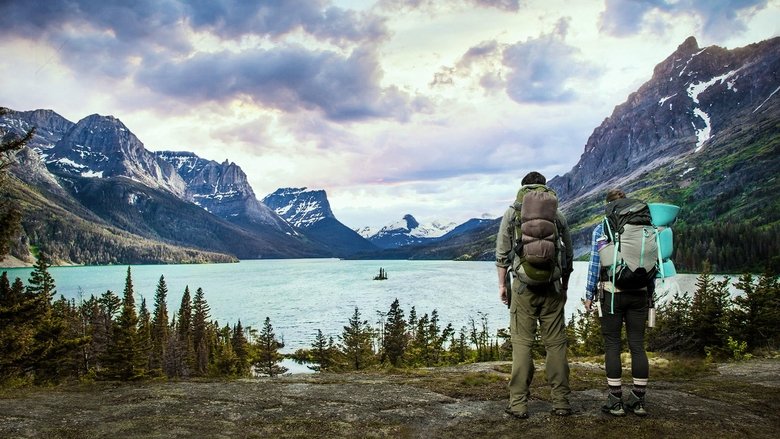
left=0, top=259, right=732, bottom=352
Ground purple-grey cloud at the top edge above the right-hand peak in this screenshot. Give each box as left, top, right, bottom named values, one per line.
left=600, top=0, right=768, bottom=38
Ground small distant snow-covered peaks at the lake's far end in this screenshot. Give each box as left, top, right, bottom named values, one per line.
left=361, top=214, right=457, bottom=248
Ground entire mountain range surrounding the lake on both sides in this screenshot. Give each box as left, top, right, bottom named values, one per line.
left=0, top=37, right=780, bottom=267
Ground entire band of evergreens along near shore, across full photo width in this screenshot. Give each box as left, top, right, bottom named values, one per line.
left=0, top=254, right=780, bottom=385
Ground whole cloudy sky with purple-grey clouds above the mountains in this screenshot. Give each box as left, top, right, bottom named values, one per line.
left=0, top=0, right=780, bottom=232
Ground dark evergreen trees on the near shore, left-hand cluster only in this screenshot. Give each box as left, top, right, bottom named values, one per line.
left=0, top=254, right=284, bottom=385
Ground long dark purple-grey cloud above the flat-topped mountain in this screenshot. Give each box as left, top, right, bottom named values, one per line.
left=138, top=47, right=409, bottom=120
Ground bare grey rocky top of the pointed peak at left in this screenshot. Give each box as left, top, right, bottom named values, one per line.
left=46, top=114, right=186, bottom=197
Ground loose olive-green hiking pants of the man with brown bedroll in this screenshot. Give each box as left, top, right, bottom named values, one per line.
left=509, top=281, right=571, bottom=412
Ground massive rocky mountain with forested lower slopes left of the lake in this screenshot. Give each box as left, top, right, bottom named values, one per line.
left=0, top=110, right=331, bottom=264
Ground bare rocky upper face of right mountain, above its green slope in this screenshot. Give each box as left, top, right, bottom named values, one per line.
left=550, top=37, right=780, bottom=203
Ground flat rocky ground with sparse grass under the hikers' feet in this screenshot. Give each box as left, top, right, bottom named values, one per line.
left=0, top=359, right=780, bottom=439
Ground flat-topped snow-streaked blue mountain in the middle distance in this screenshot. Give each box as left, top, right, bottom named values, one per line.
left=262, top=187, right=377, bottom=257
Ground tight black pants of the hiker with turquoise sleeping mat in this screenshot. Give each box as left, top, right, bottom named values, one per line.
left=601, top=291, right=650, bottom=387
